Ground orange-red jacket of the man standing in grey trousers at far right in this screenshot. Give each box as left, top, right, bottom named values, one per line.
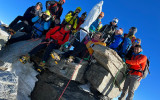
left=126, top=55, right=147, bottom=77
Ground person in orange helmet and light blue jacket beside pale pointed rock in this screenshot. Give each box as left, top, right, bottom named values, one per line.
left=89, top=12, right=104, bottom=33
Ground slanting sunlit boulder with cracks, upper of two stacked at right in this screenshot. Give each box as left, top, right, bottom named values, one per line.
left=93, top=45, right=127, bottom=84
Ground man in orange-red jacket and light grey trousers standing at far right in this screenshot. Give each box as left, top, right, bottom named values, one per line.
left=118, top=45, right=147, bottom=100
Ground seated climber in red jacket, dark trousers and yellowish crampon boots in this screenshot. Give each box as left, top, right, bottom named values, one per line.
left=21, top=24, right=71, bottom=67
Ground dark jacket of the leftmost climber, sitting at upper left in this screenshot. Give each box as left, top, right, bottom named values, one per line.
left=23, top=6, right=41, bottom=25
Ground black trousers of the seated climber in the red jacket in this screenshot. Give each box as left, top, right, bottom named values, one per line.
left=28, top=40, right=60, bottom=62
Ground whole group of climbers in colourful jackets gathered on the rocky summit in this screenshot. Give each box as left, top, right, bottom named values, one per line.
left=3, top=0, right=147, bottom=100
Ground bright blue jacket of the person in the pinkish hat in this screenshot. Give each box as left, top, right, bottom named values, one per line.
left=109, top=35, right=123, bottom=51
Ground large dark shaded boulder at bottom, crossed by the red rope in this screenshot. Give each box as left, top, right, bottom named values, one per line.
left=31, top=70, right=98, bottom=100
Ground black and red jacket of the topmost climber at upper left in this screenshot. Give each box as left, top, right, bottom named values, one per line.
left=48, top=1, right=63, bottom=19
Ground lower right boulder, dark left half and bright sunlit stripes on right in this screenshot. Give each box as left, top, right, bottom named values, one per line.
left=86, top=63, right=123, bottom=98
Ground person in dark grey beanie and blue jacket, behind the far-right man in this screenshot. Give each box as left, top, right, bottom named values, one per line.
left=118, top=27, right=137, bottom=61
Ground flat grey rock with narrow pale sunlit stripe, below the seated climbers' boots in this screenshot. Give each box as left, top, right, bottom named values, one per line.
left=48, top=58, right=88, bottom=83
